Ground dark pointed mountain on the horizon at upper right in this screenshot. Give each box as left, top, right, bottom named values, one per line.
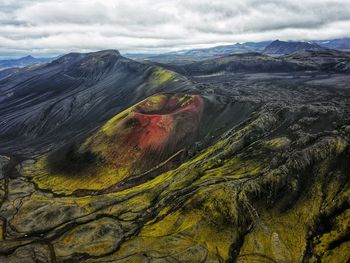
left=263, top=40, right=324, bottom=55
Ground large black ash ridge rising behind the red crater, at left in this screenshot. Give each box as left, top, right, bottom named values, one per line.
left=0, top=50, right=191, bottom=155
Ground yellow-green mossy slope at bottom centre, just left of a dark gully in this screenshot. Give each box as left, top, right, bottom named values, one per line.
left=115, top=187, right=241, bottom=262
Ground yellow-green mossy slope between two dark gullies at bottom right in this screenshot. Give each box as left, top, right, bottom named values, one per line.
left=238, top=157, right=336, bottom=262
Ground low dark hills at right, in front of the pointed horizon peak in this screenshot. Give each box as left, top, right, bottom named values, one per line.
left=168, top=49, right=350, bottom=76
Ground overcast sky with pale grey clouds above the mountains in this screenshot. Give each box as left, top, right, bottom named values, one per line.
left=0, top=0, right=350, bottom=57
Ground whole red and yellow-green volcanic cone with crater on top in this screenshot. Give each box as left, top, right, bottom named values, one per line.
left=23, top=94, right=203, bottom=195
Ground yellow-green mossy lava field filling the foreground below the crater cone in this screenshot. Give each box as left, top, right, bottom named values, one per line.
left=0, top=98, right=350, bottom=262
